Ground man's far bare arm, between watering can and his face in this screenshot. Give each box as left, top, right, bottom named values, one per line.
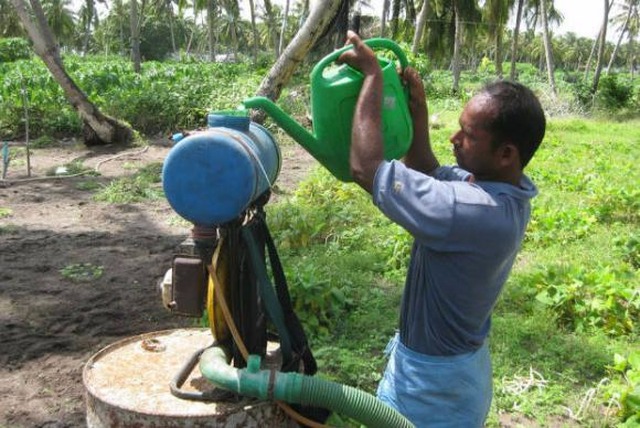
left=402, top=67, right=440, bottom=175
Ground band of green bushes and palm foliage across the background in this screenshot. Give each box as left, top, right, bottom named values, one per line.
left=0, top=0, right=640, bottom=140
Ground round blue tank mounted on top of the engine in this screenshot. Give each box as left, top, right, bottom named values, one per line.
left=162, top=114, right=281, bottom=226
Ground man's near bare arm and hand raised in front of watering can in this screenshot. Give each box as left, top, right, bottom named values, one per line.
left=338, top=31, right=384, bottom=193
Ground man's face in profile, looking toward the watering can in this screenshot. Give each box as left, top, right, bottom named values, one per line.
left=450, top=94, right=498, bottom=179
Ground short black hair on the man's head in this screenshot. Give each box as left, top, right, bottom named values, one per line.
left=481, top=80, right=546, bottom=168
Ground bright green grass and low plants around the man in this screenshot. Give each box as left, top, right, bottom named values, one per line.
left=268, top=113, right=640, bottom=427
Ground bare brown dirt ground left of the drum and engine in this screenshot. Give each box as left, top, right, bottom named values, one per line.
left=0, top=142, right=315, bottom=427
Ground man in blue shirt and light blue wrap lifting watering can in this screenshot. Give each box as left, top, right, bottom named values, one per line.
left=339, top=32, right=545, bottom=427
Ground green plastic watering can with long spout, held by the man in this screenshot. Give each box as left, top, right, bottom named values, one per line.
left=243, top=38, right=413, bottom=182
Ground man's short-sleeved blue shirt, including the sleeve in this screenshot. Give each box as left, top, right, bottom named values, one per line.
left=373, top=161, right=538, bottom=355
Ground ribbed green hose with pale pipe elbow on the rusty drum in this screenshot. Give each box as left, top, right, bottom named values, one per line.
left=200, top=347, right=413, bottom=428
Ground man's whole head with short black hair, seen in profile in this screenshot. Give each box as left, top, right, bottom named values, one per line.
left=451, top=81, right=546, bottom=181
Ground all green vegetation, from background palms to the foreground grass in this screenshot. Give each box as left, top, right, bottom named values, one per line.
left=0, top=0, right=640, bottom=426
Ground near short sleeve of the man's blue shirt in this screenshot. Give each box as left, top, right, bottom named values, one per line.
left=373, top=160, right=460, bottom=245
